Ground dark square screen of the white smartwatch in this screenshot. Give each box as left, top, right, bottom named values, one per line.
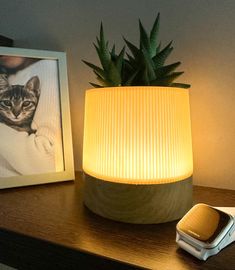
left=177, top=204, right=230, bottom=244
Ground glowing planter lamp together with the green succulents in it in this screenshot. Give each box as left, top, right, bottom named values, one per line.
left=83, top=14, right=192, bottom=223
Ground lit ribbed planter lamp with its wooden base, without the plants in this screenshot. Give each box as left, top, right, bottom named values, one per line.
left=83, top=86, right=193, bottom=224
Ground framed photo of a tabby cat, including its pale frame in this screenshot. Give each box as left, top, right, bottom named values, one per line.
left=0, top=47, right=74, bottom=189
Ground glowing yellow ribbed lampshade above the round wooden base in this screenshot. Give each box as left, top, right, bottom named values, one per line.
left=83, top=87, right=193, bottom=184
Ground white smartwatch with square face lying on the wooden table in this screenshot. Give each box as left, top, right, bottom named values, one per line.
left=176, top=203, right=235, bottom=261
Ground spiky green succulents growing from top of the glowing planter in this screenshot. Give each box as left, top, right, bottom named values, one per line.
left=83, top=14, right=190, bottom=88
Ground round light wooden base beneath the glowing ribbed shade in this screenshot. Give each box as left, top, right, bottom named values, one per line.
left=84, top=174, right=192, bottom=224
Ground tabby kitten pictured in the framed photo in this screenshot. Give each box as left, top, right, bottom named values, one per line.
left=0, top=74, right=40, bottom=135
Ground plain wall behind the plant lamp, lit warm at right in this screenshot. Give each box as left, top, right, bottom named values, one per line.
left=0, top=0, right=235, bottom=189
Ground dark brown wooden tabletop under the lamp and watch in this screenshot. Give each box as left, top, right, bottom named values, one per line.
left=0, top=173, right=235, bottom=270
